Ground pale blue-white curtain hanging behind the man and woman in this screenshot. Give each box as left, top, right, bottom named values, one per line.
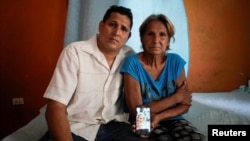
left=64, top=0, right=189, bottom=74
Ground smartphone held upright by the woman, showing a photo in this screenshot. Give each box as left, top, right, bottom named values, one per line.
left=136, top=105, right=151, bottom=135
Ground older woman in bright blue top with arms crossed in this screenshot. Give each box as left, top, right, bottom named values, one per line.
left=121, top=14, right=205, bottom=141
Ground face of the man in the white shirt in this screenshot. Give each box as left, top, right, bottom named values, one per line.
left=98, top=13, right=131, bottom=53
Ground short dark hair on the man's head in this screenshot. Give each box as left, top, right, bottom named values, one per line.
left=102, top=5, right=133, bottom=30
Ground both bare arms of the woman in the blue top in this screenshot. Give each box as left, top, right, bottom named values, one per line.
left=123, top=70, right=192, bottom=128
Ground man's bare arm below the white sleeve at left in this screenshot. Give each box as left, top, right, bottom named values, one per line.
left=45, top=99, right=73, bottom=141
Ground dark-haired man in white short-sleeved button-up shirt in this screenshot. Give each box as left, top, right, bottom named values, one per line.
left=40, top=6, right=146, bottom=141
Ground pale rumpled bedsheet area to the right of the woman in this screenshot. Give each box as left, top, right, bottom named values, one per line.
left=184, top=92, right=250, bottom=140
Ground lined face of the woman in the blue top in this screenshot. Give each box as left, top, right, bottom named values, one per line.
left=141, top=20, right=169, bottom=55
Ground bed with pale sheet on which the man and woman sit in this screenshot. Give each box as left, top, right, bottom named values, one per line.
left=2, top=87, right=250, bottom=141
